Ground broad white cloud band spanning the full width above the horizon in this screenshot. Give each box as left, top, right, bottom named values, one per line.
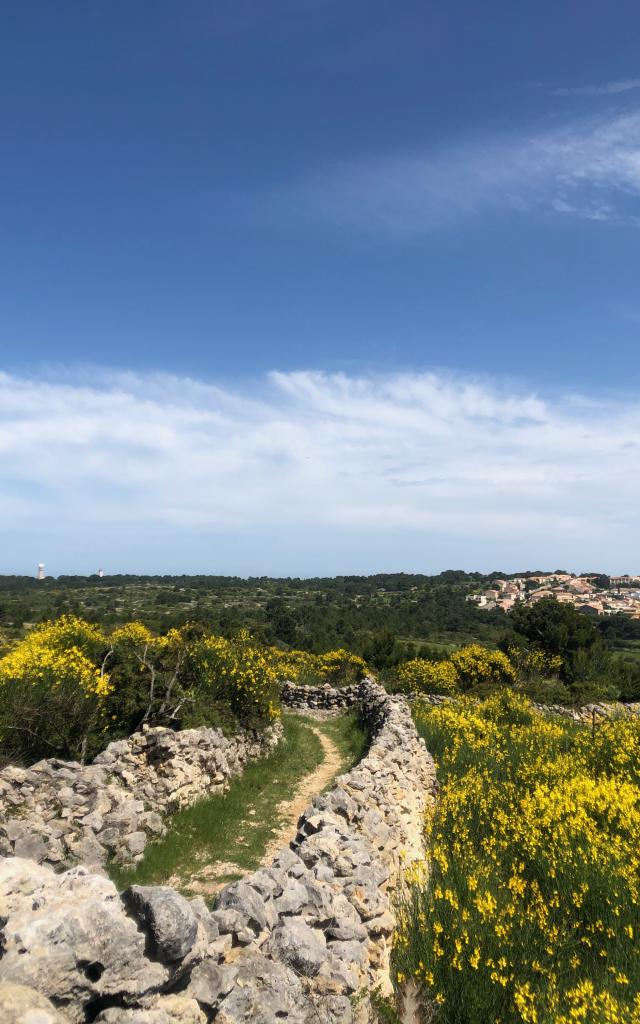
left=0, top=372, right=640, bottom=571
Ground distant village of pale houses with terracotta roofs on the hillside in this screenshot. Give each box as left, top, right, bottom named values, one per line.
left=467, top=572, right=640, bottom=618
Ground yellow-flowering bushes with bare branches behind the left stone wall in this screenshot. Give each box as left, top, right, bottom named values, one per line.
left=0, top=615, right=288, bottom=762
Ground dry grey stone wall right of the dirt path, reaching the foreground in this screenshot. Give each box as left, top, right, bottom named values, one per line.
left=0, top=680, right=435, bottom=1024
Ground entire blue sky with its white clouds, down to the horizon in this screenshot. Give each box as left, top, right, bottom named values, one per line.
left=0, top=0, right=640, bottom=574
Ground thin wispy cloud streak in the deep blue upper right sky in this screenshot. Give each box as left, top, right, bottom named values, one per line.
left=270, top=109, right=640, bottom=237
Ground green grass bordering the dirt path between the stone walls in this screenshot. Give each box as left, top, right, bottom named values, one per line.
left=109, top=713, right=366, bottom=895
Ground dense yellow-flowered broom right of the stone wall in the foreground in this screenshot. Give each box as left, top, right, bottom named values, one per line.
left=394, top=692, right=640, bottom=1024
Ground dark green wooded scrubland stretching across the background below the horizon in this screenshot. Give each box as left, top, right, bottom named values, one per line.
left=0, top=570, right=640, bottom=702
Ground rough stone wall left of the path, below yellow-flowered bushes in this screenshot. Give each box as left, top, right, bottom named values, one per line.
left=0, top=724, right=282, bottom=869
